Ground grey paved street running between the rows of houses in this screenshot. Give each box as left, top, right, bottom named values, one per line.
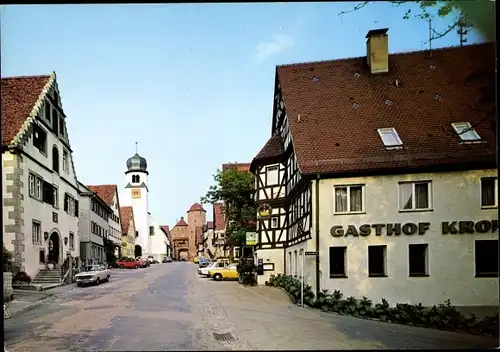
left=4, top=262, right=498, bottom=352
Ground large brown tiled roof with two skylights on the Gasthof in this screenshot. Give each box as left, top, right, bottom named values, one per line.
left=276, top=43, right=495, bottom=174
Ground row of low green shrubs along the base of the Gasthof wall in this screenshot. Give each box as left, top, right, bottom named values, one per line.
left=266, top=274, right=499, bottom=336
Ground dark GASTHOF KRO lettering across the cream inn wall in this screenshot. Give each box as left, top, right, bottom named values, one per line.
left=330, top=220, right=498, bottom=237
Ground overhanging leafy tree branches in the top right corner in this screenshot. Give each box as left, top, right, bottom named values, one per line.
left=339, top=0, right=495, bottom=40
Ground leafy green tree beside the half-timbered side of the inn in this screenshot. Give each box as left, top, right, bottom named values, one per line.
left=201, top=168, right=257, bottom=258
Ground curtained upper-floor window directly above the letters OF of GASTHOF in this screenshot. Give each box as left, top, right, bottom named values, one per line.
left=399, top=181, right=432, bottom=210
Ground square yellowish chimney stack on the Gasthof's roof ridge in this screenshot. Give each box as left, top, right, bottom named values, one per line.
left=366, top=28, right=389, bottom=74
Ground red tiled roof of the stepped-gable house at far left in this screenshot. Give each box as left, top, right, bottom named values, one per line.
left=0, top=75, right=50, bottom=145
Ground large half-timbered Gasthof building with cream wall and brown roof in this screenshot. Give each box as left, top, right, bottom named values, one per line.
left=251, top=29, right=498, bottom=306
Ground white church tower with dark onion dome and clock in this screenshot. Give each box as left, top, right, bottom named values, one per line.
left=125, top=151, right=149, bottom=257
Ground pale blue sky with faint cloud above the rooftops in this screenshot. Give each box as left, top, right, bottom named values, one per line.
left=0, top=2, right=481, bottom=227
